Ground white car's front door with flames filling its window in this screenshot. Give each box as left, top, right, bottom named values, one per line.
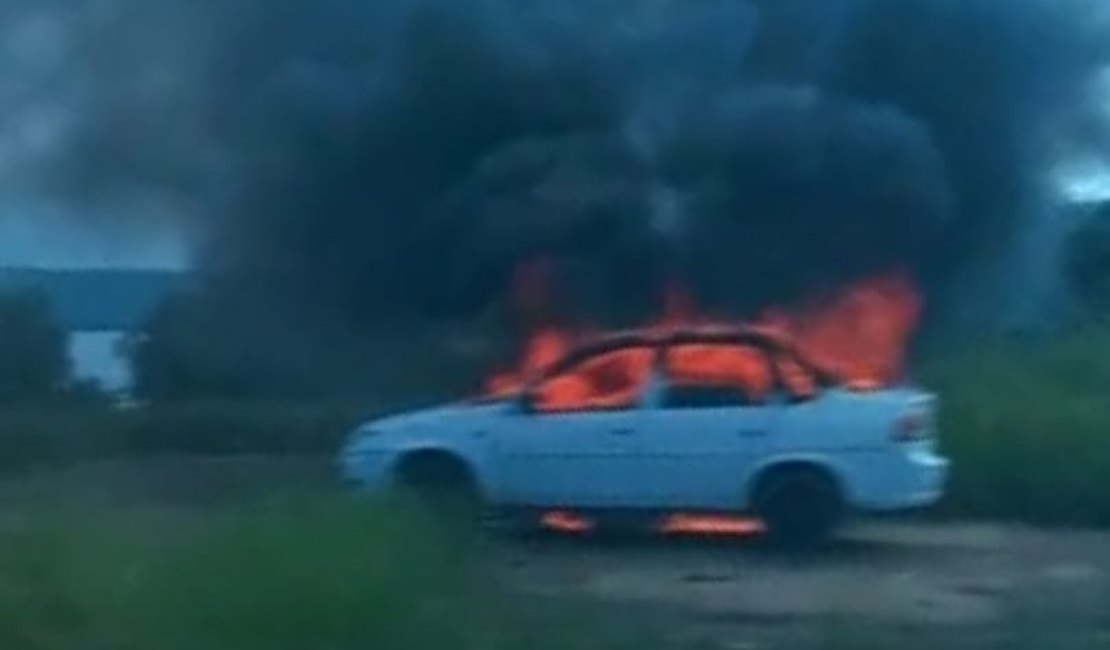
left=493, top=347, right=655, bottom=508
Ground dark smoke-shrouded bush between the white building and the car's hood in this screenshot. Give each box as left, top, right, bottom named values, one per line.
left=130, top=288, right=480, bottom=402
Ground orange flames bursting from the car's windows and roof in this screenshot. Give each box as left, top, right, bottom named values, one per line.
left=487, top=269, right=921, bottom=403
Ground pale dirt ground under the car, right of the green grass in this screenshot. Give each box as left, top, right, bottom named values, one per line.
left=502, top=521, right=1110, bottom=648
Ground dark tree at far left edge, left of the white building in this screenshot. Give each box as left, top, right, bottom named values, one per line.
left=0, top=291, right=71, bottom=404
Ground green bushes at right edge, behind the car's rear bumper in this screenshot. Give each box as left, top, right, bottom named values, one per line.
left=925, top=327, right=1110, bottom=525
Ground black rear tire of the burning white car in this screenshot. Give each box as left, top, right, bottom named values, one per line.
left=754, top=467, right=842, bottom=550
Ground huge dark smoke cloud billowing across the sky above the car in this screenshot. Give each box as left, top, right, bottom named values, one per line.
left=2, top=0, right=1110, bottom=326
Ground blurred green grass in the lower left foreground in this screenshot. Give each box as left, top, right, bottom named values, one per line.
left=0, top=495, right=649, bottom=650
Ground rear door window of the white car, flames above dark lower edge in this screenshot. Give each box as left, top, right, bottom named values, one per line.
left=663, top=344, right=775, bottom=408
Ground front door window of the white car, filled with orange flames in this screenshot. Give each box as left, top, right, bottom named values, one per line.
left=532, top=346, right=655, bottom=413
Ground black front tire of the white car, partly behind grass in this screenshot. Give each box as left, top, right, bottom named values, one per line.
left=396, top=451, right=483, bottom=527
